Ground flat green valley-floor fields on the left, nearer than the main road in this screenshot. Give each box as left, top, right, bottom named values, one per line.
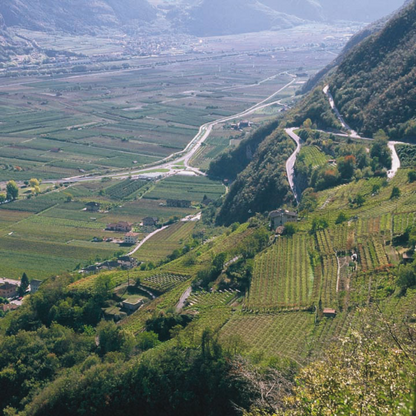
left=0, top=180, right=195, bottom=279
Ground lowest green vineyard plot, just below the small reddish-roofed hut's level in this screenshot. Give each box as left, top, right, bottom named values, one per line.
left=220, top=312, right=314, bottom=363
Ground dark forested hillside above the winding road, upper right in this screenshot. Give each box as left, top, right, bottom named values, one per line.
left=329, top=1, right=416, bottom=138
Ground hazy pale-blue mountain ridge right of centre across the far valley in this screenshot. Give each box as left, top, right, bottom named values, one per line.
left=167, top=0, right=403, bottom=36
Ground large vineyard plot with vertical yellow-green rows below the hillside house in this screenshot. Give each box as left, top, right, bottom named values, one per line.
left=246, top=235, right=314, bottom=309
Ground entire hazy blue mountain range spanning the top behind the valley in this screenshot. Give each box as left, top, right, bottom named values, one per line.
left=0, top=0, right=403, bottom=36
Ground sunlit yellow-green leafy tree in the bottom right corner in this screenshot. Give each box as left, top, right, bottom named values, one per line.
left=289, top=311, right=415, bottom=416
